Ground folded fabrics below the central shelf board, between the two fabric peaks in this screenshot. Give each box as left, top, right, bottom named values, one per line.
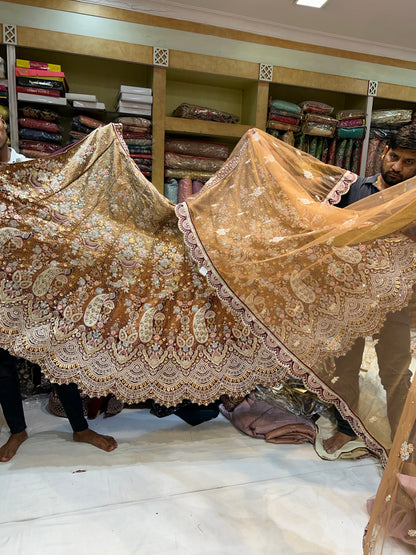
left=164, top=137, right=230, bottom=204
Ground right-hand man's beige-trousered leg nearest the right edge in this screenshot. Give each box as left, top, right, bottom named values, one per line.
left=375, top=317, right=412, bottom=438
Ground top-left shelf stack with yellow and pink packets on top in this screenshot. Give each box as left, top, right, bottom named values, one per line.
left=15, top=59, right=68, bottom=106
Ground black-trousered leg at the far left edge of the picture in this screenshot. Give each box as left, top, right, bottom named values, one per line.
left=0, top=349, right=27, bottom=462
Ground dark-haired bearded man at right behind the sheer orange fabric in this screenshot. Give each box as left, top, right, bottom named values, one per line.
left=323, top=125, right=416, bottom=454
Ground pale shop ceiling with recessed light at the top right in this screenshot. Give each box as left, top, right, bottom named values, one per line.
left=79, top=0, right=416, bottom=61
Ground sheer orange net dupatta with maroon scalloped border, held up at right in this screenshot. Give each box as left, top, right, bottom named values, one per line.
left=180, top=129, right=416, bottom=457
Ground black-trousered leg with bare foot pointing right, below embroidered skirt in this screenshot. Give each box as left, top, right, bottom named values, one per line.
left=54, top=383, right=117, bottom=451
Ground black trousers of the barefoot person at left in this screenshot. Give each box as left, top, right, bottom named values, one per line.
left=0, top=349, right=88, bottom=434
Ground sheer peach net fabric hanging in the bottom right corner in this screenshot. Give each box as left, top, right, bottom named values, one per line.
left=364, top=380, right=416, bottom=555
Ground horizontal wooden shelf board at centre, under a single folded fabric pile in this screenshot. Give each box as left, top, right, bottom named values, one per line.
left=165, top=116, right=252, bottom=138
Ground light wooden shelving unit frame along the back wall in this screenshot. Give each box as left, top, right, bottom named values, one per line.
left=4, top=26, right=416, bottom=193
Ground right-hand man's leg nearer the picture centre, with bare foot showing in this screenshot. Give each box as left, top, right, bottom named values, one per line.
left=323, top=337, right=365, bottom=453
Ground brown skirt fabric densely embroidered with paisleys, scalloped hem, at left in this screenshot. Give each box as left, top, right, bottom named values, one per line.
left=0, top=124, right=282, bottom=406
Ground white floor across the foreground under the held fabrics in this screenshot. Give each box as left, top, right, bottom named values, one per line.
left=0, top=396, right=401, bottom=555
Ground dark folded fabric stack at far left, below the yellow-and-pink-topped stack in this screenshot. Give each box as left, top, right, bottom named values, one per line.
left=19, top=106, right=62, bottom=158
